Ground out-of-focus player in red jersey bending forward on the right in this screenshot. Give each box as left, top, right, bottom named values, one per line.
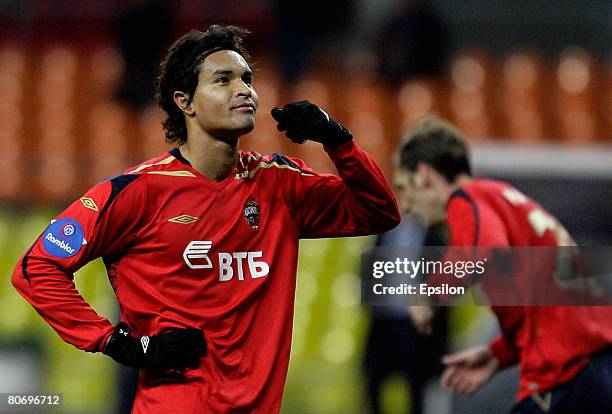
left=395, top=118, right=612, bottom=414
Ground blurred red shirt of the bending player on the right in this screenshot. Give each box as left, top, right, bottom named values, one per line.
left=447, top=179, right=612, bottom=400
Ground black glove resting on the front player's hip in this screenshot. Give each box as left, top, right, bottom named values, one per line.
left=103, top=322, right=206, bottom=369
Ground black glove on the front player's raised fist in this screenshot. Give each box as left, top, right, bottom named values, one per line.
left=272, top=101, right=353, bottom=147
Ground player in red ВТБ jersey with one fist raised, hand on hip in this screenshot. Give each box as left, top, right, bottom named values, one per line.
left=12, top=25, right=400, bottom=414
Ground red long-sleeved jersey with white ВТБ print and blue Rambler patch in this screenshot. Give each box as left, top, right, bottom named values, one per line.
left=12, top=141, right=400, bottom=414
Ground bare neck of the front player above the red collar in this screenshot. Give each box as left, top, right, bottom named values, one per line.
left=180, top=130, right=238, bottom=181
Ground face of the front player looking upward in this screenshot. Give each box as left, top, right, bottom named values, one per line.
left=192, top=50, right=259, bottom=139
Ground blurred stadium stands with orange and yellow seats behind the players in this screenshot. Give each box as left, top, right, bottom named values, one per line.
left=0, top=0, right=612, bottom=413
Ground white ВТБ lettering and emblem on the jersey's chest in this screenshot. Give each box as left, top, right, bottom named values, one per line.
left=183, top=240, right=270, bottom=282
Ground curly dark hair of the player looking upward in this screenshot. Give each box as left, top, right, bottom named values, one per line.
left=155, top=24, right=251, bottom=145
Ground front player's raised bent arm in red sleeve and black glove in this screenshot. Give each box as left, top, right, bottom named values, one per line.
left=273, top=101, right=400, bottom=238
